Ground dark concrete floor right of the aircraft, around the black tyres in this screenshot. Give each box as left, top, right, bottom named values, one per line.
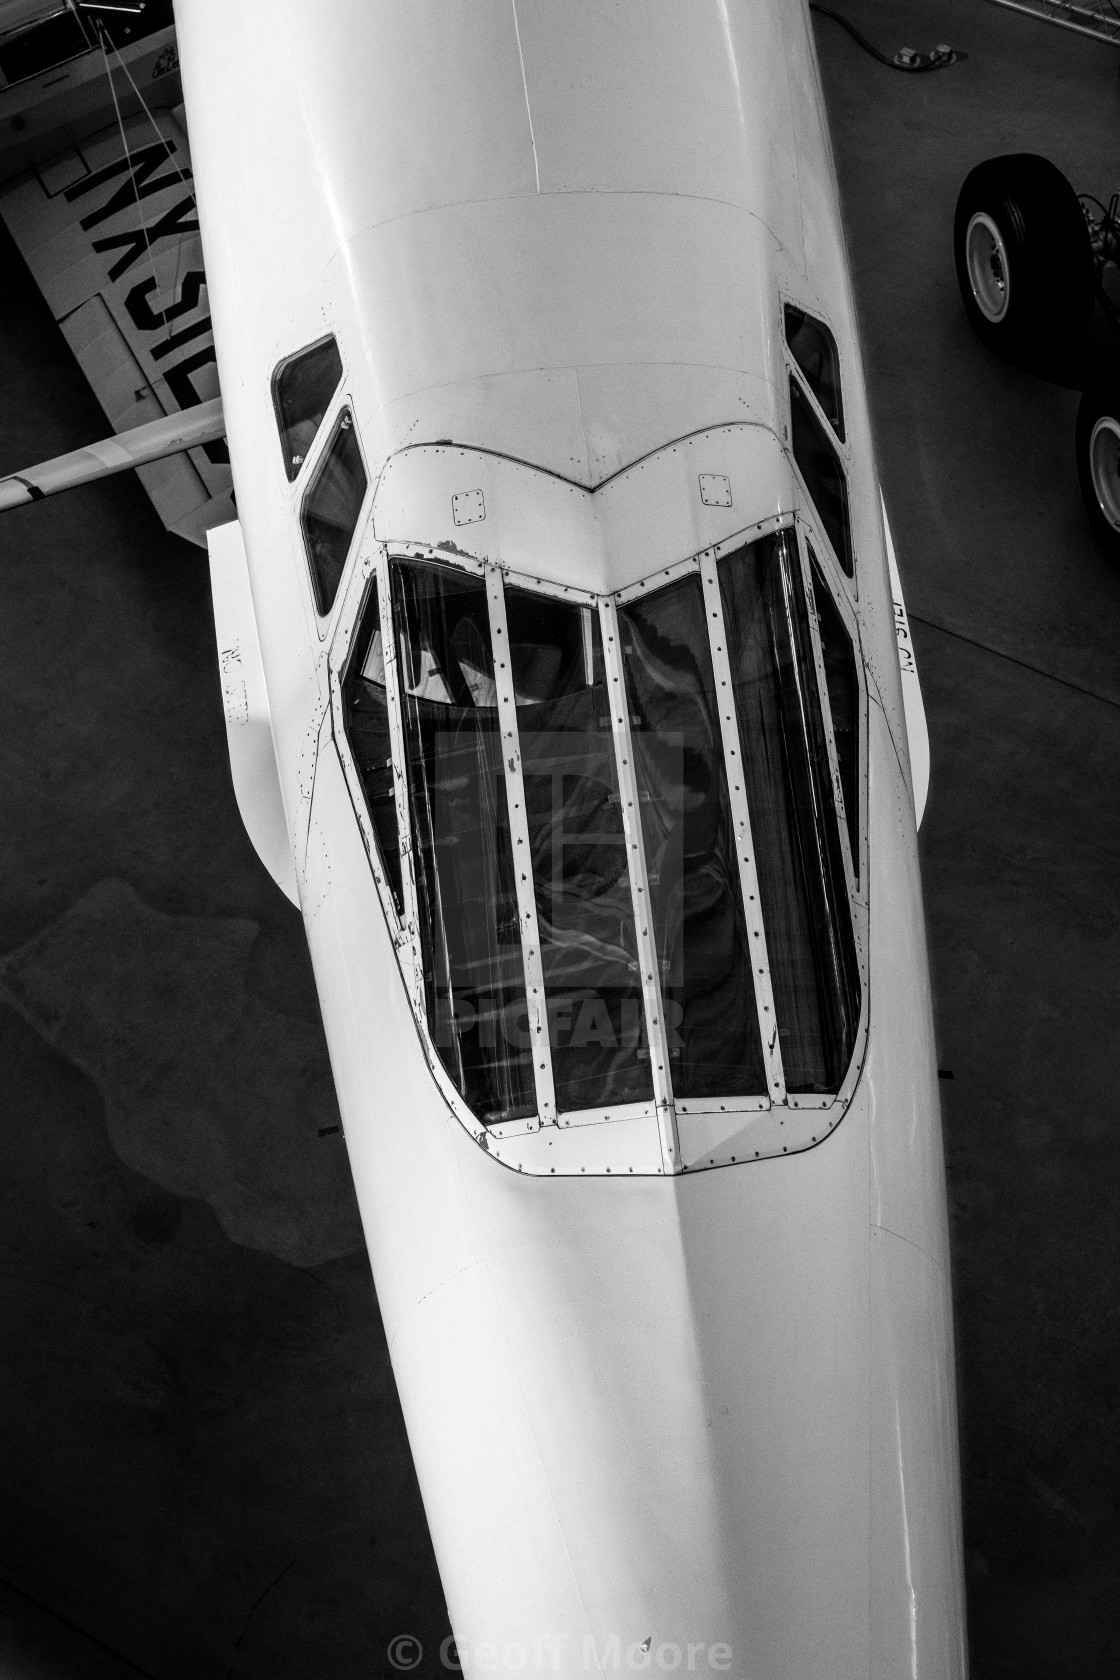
left=816, top=0, right=1120, bottom=1680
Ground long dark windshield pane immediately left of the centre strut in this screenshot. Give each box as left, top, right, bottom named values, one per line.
left=505, top=590, right=653, bottom=1110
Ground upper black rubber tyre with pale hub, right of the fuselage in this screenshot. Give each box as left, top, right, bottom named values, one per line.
left=952, top=151, right=1095, bottom=365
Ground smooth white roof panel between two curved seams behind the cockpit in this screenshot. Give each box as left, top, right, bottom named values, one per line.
left=336, top=193, right=776, bottom=463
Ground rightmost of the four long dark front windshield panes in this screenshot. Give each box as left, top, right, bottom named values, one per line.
left=719, top=531, right=860, bottom=1092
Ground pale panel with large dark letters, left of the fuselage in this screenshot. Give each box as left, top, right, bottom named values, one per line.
left=0, top=111, right=232, bottom=546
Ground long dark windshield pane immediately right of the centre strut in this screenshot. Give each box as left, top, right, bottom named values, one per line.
left=620, top=576, right=767, bottom=1097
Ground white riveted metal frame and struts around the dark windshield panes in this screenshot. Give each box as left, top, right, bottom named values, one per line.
left=325, top=527, right=870, bottom=1176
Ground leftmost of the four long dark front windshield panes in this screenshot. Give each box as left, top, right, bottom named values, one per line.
left=393, top=564, right=537, bottom=1122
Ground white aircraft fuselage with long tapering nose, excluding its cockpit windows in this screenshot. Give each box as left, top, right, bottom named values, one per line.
left=176, top=0, right=966, bottom=1680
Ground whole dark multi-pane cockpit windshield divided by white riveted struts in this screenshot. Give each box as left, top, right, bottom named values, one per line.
left=343, top=524, right=861, bottom=1127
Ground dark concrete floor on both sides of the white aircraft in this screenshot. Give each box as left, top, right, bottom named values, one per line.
left=0, top=0, right=1120, bottom=1680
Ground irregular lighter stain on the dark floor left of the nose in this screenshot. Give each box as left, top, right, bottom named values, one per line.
left=0, top=880, right=363, bottom=1265
